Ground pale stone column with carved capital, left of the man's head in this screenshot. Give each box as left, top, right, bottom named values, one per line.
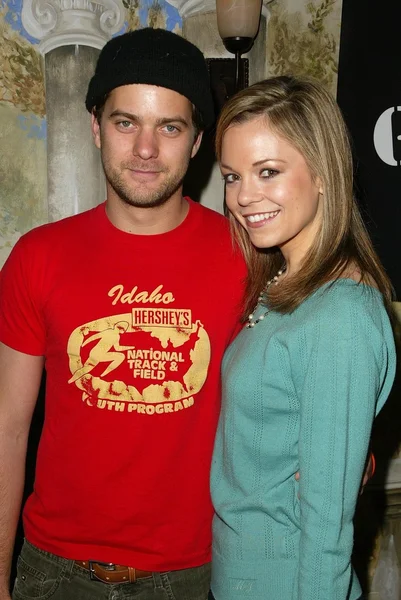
left=21, top=0, right=125, bottom=221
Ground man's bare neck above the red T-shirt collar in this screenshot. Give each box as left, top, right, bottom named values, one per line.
left=106, top=193, right=189, bottom=235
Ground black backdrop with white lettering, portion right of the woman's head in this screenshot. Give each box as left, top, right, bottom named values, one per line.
left=337, top=0, right=401, bottom=300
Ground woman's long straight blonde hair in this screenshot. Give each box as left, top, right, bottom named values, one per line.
left=216, top=76, right=393, bottom=315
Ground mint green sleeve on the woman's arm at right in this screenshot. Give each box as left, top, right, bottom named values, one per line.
left=297, top=290, right=391, bottom=600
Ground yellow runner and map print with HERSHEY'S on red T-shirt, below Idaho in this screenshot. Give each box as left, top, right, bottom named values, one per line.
left=67, top=307, right=210, bottom=415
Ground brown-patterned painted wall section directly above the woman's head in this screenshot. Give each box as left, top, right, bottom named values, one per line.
left=267, top=0, right=342, bottom=94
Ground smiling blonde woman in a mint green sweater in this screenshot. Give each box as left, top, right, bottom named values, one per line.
left=211, top=77, right=395, bottom=600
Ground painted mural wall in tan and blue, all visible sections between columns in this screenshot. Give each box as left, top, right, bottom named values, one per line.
left=0, top=0, right=342, bottom=268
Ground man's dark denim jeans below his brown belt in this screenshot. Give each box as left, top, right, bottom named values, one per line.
left=12, top=541, right=210, bottom=600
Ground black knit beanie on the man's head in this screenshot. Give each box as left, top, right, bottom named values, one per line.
left=85, top=27, right=214, bottom=127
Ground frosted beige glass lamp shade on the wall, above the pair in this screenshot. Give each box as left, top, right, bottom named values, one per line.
left=216, top=0, right=262, bottom=40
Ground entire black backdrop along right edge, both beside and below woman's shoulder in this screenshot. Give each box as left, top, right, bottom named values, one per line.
left=337, top=0, right=401, bottom=592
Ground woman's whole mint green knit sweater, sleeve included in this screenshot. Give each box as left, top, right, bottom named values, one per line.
left=212, top=279, right=396, bottom=600
